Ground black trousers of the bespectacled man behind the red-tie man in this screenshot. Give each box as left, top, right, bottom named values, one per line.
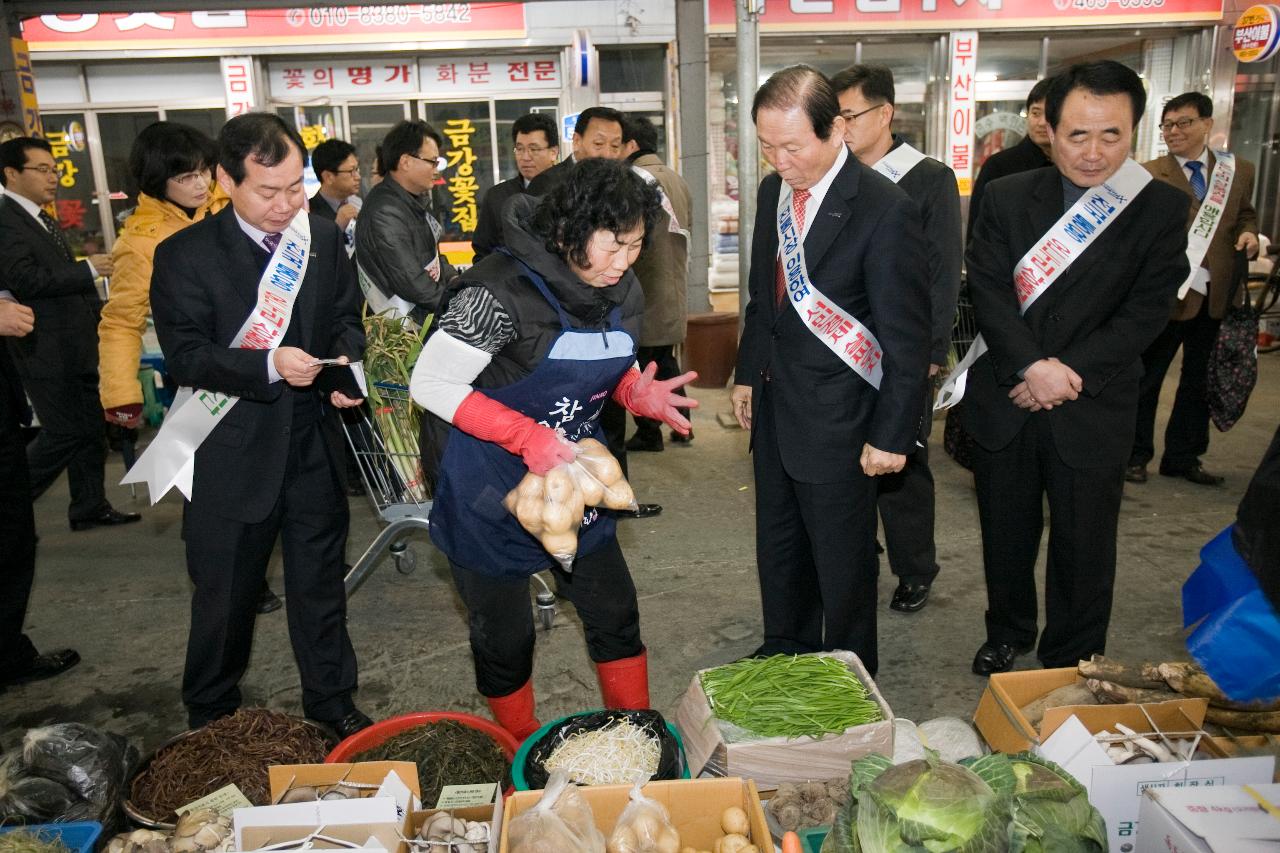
left=876, top=383, right=938, bottom=584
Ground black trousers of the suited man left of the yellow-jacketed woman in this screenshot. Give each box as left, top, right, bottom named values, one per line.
left=22, top=370, right=106, bottom=521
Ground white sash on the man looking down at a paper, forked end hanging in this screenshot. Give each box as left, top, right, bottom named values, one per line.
left=120, top=210, right=311, bottom=503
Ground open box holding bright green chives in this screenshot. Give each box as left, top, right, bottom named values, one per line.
left=676, top=652, right=893, bottom=786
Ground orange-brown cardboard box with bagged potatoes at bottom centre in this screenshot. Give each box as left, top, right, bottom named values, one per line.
left=490, top=779, right=773, bottom=853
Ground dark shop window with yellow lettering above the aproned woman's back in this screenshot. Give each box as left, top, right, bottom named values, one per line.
left=422, top=100, right=494, bottom=241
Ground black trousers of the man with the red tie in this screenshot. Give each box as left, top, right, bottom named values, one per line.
left=753, top=392, right=879, bottom=675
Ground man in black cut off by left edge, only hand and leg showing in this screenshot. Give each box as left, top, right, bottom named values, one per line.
left=0, top=297, right=79, bottom=690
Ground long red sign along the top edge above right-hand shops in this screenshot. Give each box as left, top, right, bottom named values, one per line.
left=707, top=0, right=1222, bottom=33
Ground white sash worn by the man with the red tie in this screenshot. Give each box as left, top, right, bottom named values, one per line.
left=778, top=182, right=884, bottom=391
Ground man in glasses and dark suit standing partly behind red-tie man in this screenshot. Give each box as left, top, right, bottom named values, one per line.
left=831, top=65, right=963, bottom=613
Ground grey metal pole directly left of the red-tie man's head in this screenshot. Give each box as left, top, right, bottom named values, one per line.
left=735, top=0, right=760, bottom=328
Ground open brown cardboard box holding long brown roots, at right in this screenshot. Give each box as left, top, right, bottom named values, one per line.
left=973, top=667, right=1208, bottom=752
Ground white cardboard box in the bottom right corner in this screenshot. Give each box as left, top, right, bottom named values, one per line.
left=1137, top=785, right=1280, bottom=853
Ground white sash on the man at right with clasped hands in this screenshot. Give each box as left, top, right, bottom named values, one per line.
left=933, top=159, right=1152, bottom=411
